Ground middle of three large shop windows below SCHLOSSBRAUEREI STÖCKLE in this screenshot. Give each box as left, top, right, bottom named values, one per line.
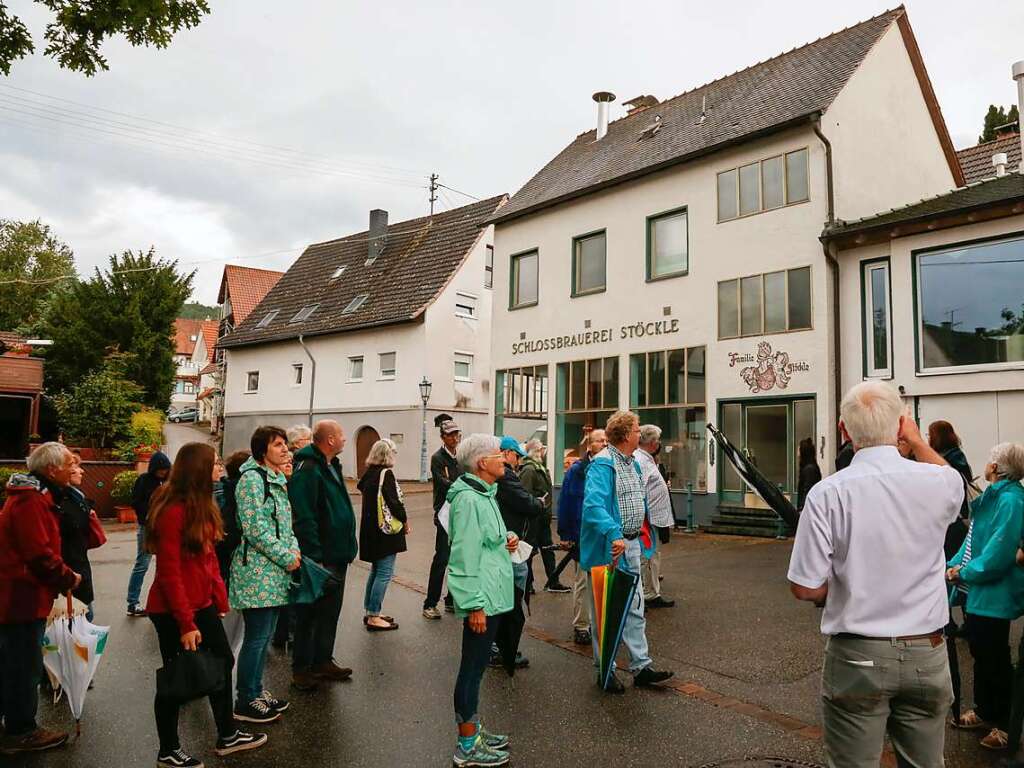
left=554, top=357, right=618, bottom=482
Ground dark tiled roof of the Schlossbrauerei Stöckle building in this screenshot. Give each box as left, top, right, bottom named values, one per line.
left=493, top=6, right=904, bottom=222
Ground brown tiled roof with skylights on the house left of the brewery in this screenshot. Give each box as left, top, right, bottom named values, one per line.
left=219, top=195, right=507, bottom=348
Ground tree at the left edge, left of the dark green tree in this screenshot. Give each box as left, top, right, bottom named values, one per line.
left=0, top=219, right=75, bottom=335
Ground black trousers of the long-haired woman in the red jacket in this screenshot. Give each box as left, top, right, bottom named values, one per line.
left=150, top=605, right=238, bottom=754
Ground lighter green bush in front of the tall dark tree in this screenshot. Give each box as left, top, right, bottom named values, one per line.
left=53, top=353, right=142, bottom=449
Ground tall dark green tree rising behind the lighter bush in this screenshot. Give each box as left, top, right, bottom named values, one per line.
left=42, top=249, right=196, bottom=411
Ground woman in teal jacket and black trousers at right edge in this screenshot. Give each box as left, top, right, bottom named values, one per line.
left=946, top=442, right=1024, bottom=749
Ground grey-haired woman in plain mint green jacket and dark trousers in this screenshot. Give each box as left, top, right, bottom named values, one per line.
left=447, top=434, right=519, bottom=766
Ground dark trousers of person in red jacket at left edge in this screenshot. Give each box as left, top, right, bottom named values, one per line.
left=0, top=618, right=46, bottom=736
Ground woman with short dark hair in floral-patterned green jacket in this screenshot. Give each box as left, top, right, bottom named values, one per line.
left=228, top=427, right=300, bottom=723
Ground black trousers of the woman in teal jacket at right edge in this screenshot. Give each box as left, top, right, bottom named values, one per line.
left=964, top=613, right=1014, bottom=730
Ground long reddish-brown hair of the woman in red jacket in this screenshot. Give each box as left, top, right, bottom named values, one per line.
left=145, top=442, right=224, bottom=554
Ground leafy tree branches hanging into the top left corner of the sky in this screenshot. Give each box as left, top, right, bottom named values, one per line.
left=0, top=0, right=210, bottom=77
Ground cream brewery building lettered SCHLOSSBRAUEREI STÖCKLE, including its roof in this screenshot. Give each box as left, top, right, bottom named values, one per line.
left=493, top=10, right=958, bottom=532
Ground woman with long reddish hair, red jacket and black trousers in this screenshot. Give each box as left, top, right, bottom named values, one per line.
left=145, top=442, right=266, bottom=768
